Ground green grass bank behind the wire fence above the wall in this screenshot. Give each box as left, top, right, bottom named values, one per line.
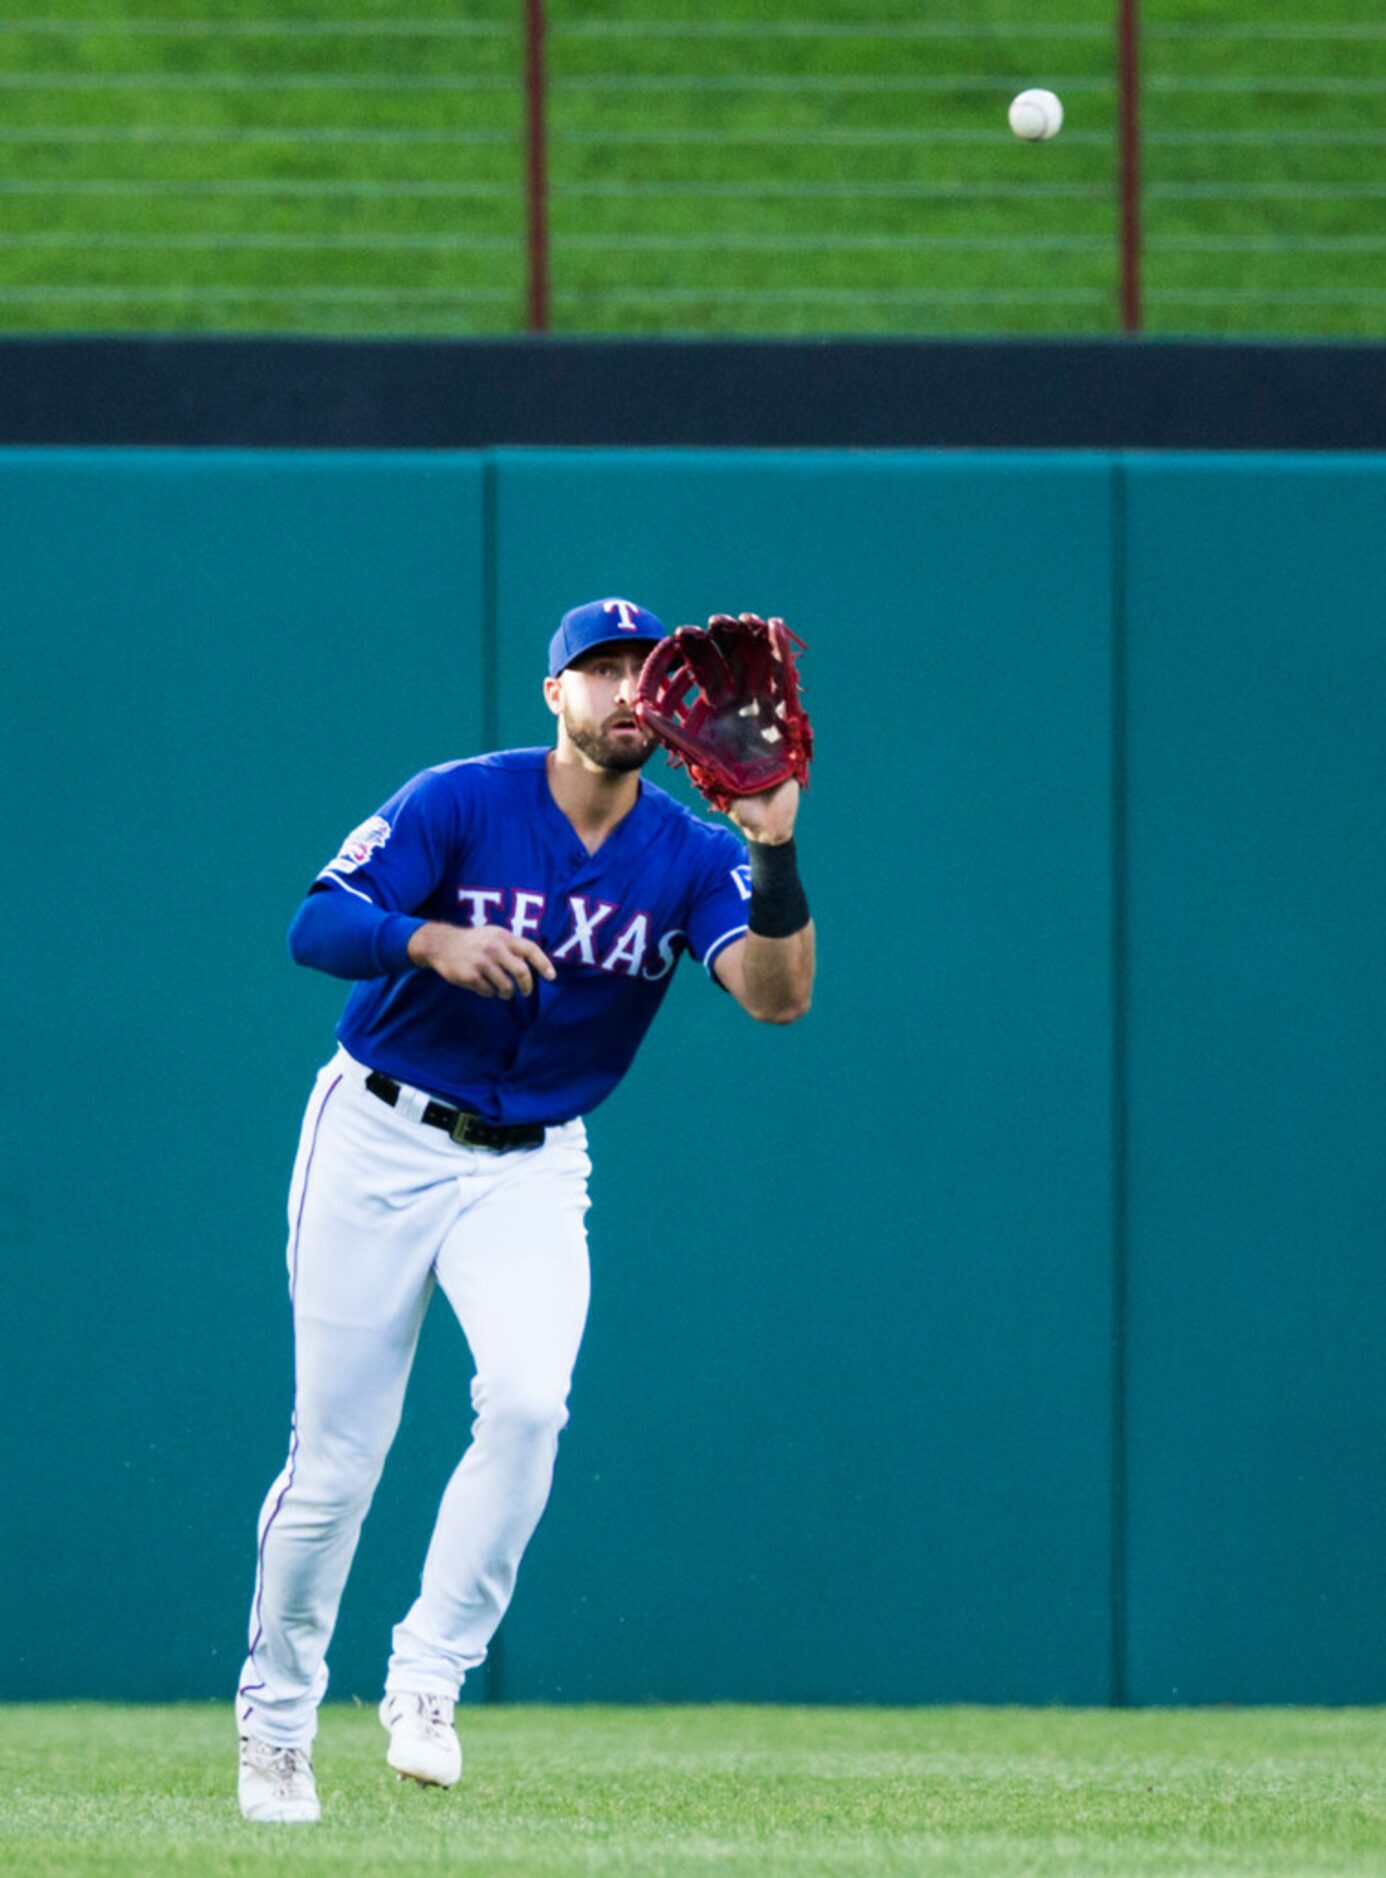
left=0, top=0, right=1386, bottom=336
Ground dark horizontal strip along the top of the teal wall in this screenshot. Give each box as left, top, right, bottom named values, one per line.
left=0, top=338, right=1386, bottom=451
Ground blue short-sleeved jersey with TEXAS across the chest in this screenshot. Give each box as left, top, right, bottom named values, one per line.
left=317, top=749, right=749, bottom=1123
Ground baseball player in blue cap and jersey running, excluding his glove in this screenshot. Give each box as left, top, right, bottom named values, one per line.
left=237, top=599, right=813, bottom=1824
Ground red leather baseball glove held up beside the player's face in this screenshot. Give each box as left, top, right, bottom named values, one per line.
left=635, top=612, right=813, bottom=811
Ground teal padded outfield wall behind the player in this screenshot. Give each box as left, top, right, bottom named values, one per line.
left=0, top=451, right=1386, bottom=1703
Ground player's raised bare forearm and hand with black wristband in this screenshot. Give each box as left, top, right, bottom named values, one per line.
left=712, top=777, right=815, bottom=1024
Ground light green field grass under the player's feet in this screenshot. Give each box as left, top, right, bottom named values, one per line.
left=0, top=1705, right=1386, bottom=1878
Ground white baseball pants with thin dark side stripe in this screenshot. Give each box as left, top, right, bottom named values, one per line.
left=237, top=1050, right=592, bottom=1747
